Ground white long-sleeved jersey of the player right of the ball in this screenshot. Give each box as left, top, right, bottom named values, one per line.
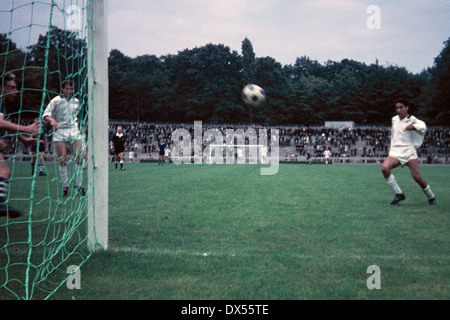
left=391, top=116, right=427, bottom=149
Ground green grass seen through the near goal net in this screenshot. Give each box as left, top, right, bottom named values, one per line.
left=0, top=163, right=90, bottom=300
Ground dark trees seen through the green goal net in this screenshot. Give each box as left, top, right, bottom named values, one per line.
left=0, top=27, right=87, bottom=118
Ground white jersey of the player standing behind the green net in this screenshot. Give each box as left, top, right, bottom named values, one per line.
left=43, top=96, right=80, bottom=129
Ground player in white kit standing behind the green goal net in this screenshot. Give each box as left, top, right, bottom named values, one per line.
left=43, top=80, right=86, bottom=196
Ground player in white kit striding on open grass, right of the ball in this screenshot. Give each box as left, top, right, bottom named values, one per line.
left=381, top=100, right=436, bottom=205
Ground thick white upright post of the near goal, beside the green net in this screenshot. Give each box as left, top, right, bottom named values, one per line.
left=88, top=0, right=108, bottom=251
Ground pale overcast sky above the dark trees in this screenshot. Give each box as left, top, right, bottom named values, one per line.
left=0, top=0, right=450, bottom=73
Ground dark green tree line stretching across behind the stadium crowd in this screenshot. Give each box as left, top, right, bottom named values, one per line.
left=0, top=27, right=450, bottom=126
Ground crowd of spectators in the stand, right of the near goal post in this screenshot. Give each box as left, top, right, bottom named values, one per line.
left=109, top=121, right=450, bottom=162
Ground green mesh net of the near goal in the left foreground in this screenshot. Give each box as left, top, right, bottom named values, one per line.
left=0, top=0, right=107, bottom=300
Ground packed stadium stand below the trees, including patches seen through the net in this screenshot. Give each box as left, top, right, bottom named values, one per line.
left=5, top=120, right=450, bottom=164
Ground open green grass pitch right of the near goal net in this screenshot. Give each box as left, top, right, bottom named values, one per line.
left=0, top=163, right=450, bottom=300
